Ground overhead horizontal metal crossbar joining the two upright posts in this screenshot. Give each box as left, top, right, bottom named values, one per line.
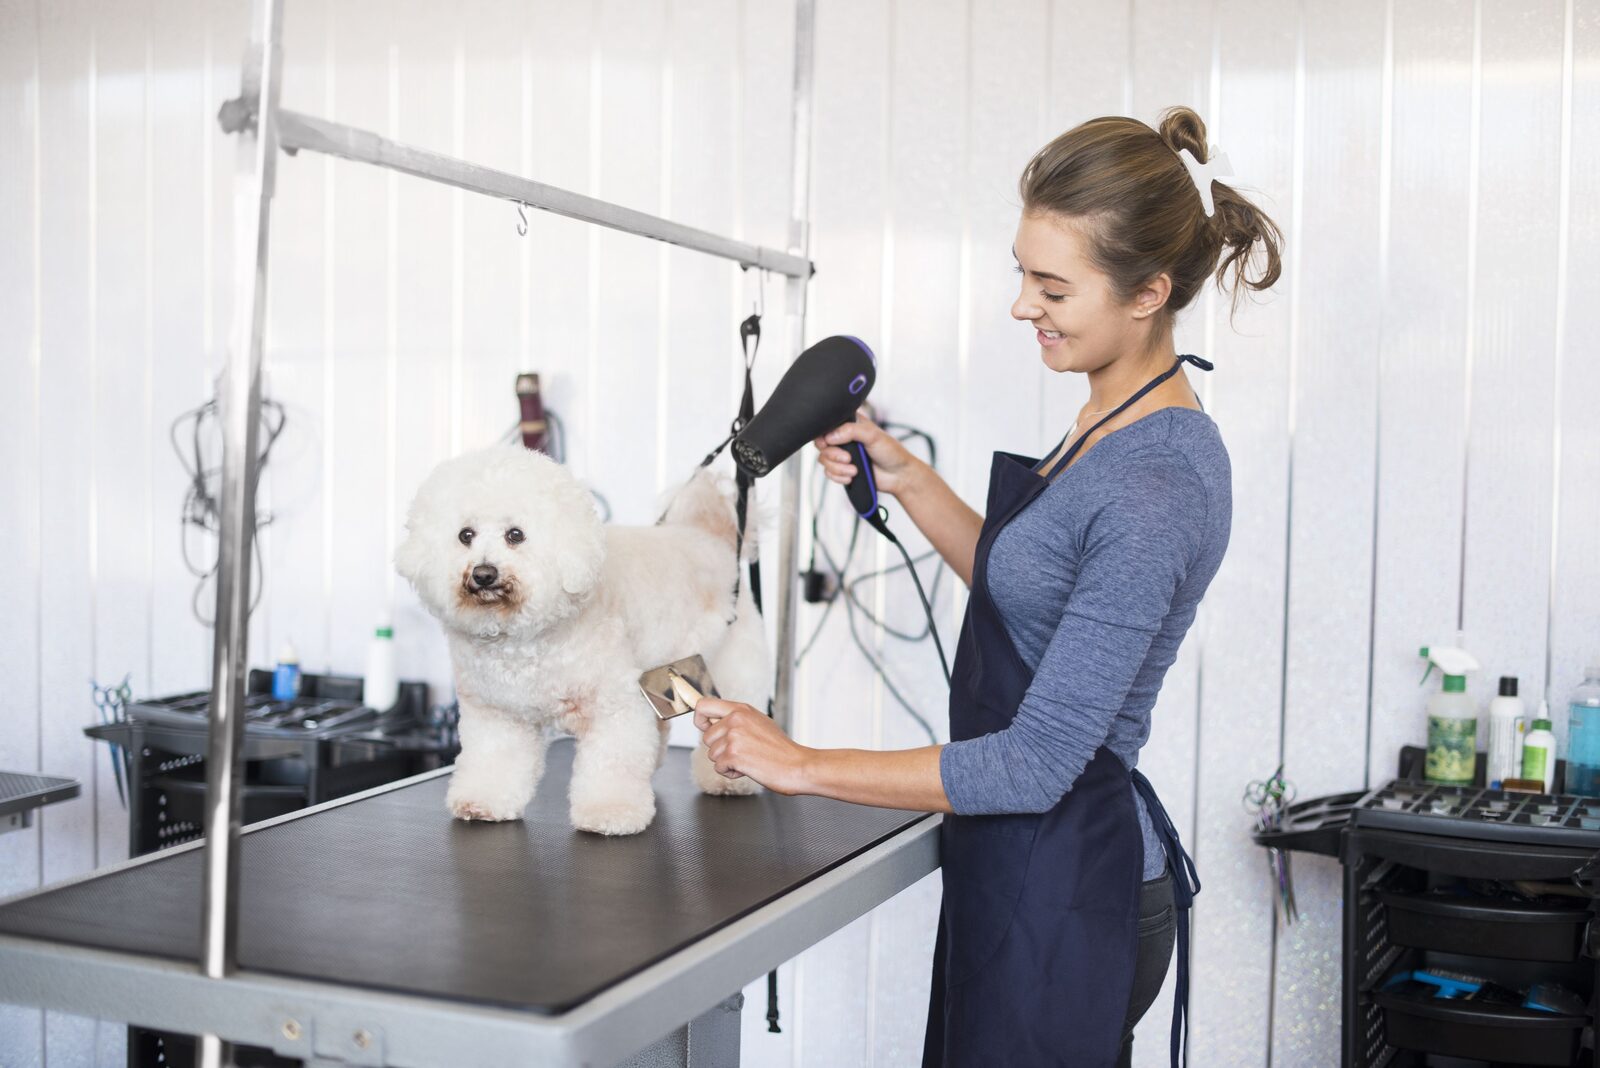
left=277, top=110, right=813, bottom=278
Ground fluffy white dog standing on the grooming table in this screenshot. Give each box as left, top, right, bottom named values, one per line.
left=395, top=444, right=770, bottom=835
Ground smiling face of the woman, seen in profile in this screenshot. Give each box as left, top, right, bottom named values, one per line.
left=1011, top=211, right=1150, bottom=373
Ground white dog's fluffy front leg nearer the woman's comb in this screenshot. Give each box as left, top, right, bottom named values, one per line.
left=568, top=673, right=661, bottom=835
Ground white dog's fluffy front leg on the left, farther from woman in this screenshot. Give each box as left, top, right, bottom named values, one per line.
left=445, top=700, right=547, bottom=820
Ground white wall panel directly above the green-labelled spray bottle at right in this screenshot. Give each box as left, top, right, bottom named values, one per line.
left=1352, top=0, right=1474, bottom=799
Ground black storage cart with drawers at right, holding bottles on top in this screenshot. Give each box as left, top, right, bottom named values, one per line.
left=1256, top=748, right=1600, bottom=1068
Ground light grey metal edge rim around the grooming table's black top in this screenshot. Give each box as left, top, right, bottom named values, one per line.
left=0, top=815, right=939, bottom=1068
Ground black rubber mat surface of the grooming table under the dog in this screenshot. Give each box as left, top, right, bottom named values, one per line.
left=0, top=742, right=925, bottom=1014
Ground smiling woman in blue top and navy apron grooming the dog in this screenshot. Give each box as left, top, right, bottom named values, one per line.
left=696, top=107, right=1282, bottom=1068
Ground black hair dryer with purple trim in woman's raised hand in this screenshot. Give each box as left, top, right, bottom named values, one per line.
left=733, top=334, right=878, bottom=518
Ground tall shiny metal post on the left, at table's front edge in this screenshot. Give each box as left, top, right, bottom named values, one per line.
left=200, top=0, right=283, bottom=1068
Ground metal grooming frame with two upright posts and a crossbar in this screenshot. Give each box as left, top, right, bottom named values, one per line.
left=202, top=0, right=814, bottom=1068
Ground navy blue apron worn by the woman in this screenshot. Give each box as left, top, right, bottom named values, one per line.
left=922, top=357, right=1210, bottom=1068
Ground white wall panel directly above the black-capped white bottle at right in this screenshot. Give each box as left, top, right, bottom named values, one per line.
left=1462, top=0, right=1566, bottom=737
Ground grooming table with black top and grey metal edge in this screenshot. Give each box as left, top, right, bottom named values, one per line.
left=0, top=742, right=939, bottom=1068
